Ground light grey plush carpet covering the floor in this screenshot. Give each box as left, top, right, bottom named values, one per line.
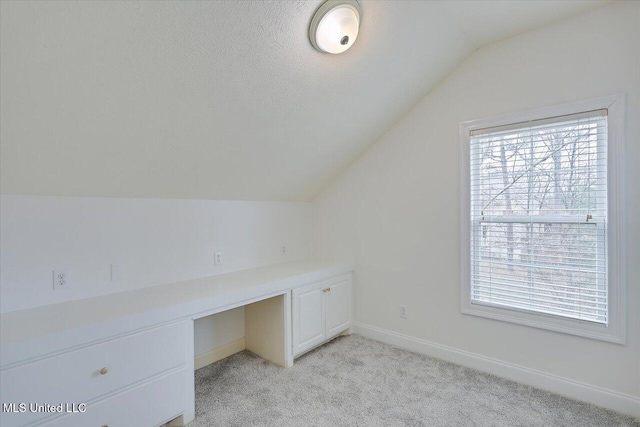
left=189, top=335, right=640, bottom=427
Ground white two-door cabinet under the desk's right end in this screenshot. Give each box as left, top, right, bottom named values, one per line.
left=292, top=274, right=352, bottom=356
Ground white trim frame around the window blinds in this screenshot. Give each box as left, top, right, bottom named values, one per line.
left=460, top=94, right=626, bottom=344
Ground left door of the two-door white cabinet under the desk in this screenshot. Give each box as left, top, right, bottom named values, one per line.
left=292, top=283, right=325, bottom=356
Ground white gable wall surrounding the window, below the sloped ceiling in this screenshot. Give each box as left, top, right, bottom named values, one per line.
left=314, top=2, right=640, bottom=402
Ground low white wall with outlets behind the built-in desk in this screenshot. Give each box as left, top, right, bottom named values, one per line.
left=0, top=195, right=313, bottom=354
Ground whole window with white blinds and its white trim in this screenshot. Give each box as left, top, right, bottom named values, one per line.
left=460, top=97, right=624, bottom=342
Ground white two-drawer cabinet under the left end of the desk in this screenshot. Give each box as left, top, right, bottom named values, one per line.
left=0, top=322, right=188, bottom=427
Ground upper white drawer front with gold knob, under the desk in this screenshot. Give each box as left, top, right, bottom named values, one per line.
left=0, top=322, right=187, bottom=426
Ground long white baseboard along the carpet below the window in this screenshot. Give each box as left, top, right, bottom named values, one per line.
left=353, top=322, right=640, bottom=418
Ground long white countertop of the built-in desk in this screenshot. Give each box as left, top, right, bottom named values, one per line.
left=0, top=259, right=353, bottom=369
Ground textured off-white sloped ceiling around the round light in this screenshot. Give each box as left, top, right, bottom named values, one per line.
left=0, top=1, right=605, bottom=200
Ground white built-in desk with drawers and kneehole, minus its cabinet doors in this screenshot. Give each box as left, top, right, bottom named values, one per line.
left=0, top=260, right=353, bottom=427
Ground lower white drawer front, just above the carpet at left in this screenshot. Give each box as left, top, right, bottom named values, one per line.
left=42, top=369, right=186, bottom=427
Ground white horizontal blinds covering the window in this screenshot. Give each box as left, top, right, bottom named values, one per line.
left=470, top=110, right=608, bottom=324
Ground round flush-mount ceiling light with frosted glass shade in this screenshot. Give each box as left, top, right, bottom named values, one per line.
left=309, top=0, right=362, bottom=54
